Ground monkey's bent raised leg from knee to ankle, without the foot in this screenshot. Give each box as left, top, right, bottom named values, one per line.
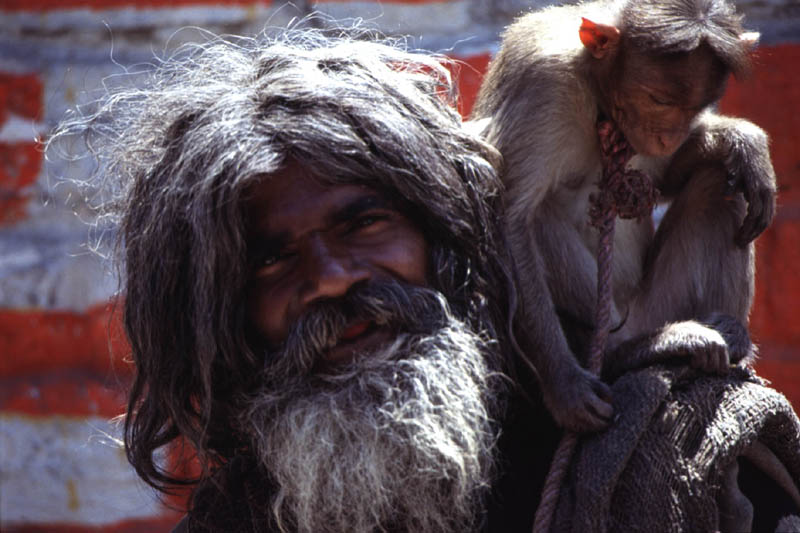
left=630, top=165, right=755, bottom=333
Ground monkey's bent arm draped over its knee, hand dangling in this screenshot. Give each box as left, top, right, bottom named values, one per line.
left=661, top=110, right=777, bottom=246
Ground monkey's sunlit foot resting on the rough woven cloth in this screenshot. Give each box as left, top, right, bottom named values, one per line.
left=602, top=313, right=755, bottom=382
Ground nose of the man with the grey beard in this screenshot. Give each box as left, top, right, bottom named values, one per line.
left=300, top=234, right=370, bottom=306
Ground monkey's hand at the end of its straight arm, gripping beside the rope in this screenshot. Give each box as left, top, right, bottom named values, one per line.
left=544, top=360, right=614, bottom=433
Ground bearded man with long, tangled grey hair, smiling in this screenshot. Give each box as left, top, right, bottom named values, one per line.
left=57, top=32, right=553, bottom=533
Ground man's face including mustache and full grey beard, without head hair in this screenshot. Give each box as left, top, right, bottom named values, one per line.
left=238, top=165, right=496, bottom=533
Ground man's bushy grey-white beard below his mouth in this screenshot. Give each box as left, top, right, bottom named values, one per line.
left=240, top=300, right=499, bottom=533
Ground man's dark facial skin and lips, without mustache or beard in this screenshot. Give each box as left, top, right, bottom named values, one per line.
left=245, top=163, right=428, bottom=363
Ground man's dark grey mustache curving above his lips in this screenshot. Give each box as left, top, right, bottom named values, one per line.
left=264, top=280, right=451, bottom=379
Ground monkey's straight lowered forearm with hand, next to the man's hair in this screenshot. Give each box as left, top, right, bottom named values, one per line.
left=515, top=221, right=613, bottom=432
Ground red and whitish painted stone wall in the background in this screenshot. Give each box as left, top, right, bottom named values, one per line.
left=0, top=0, right=800, bottom=532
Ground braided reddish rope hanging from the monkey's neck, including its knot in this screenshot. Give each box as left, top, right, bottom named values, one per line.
left=533, top=120, right=658, bottom=533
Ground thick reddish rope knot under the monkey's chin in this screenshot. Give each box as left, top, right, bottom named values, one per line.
left=589, top=120, right=658, bottom=229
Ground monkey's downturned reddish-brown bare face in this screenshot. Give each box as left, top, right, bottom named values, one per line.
left=609, top=46, right=727, bottom=157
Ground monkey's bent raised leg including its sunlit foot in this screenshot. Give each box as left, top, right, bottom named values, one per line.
left=604, top=166, right=754, bottom=376
